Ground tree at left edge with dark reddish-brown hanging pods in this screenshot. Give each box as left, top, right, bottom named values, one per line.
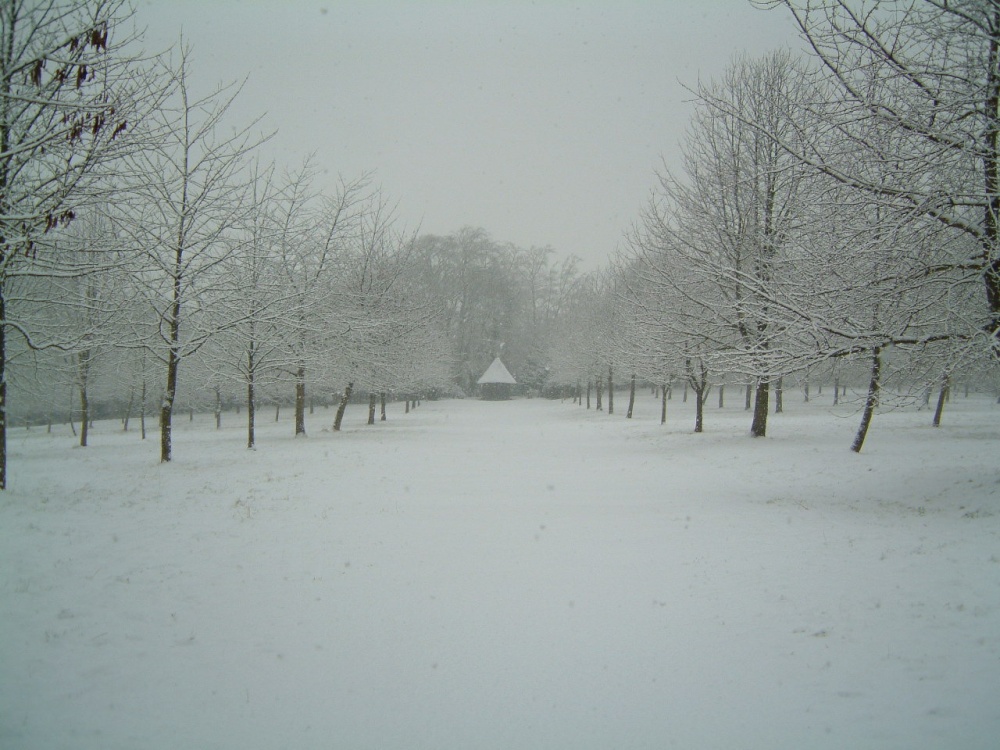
left=0, top=0, right=158, bottom=489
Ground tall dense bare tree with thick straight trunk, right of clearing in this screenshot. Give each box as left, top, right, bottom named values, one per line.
left=630, top=53, right=806, bottom=437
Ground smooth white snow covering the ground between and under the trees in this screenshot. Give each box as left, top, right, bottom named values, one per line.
left=0, top=393, right=1000, bottom=750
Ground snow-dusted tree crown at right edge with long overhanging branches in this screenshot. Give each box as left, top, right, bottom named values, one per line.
left=758, top=0, right=1000, bottom=356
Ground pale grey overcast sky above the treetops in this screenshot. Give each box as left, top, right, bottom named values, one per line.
left=136, top=0, right=798, bottom=268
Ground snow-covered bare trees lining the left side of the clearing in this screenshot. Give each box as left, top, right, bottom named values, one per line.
left=0, top=0, right=466, bottom=488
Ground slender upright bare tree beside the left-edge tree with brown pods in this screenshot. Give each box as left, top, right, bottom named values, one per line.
left=112, top=47, right=261, bottom=462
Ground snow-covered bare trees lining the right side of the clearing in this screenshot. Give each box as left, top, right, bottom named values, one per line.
left=548, top=0, right=1000, bottom=451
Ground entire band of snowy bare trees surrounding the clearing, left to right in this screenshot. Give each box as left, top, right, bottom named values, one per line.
left=0, top=0, right=1000, bottom=487
